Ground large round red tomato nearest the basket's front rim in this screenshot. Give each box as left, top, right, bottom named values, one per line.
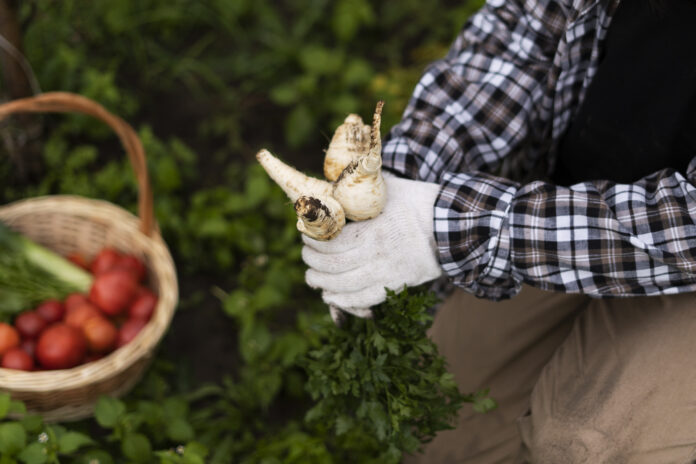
left=36, top=323, right=87, bottom=369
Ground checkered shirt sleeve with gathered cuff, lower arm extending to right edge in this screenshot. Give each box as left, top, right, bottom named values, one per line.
left=435, top=159, right=696, bottom=299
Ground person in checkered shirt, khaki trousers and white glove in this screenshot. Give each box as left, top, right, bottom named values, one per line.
left=303, top=0, right=696, bottom=464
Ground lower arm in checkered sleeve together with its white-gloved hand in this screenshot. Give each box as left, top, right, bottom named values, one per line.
left=304, top=163, right=696, bottom=307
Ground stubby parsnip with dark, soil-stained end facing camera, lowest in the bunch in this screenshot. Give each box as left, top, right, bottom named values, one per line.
left=295, top=196, right=346, bottom=240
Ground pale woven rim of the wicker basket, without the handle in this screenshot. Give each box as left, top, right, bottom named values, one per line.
left=0, top=195, right=178, bottom=392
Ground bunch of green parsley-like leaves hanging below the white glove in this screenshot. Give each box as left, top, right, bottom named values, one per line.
left=304, top=289, right=496, bottom=463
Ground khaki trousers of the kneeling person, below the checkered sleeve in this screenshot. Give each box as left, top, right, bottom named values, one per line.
left=404, top=287, right=696, bottom=464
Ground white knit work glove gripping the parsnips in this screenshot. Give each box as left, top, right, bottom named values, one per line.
left=302, top=176, right=442, bottom=323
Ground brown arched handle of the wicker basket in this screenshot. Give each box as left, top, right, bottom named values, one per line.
left=0, top=92, right=155, bottom=236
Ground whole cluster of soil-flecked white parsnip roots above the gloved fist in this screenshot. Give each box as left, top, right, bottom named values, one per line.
left=256, top=101, right=387, bottom=240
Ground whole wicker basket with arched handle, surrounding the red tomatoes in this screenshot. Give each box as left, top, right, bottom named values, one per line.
left=0, top=92, right=178, bottom=421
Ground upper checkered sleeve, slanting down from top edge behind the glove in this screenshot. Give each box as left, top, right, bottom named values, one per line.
left=382, top=0, right=567, bottom=182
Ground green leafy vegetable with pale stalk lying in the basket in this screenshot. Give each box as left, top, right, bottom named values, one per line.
left=0, top=222, right=92, bottom=315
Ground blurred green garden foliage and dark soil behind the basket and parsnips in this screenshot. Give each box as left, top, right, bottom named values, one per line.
left=0, top=0, right=490, bottom=463
